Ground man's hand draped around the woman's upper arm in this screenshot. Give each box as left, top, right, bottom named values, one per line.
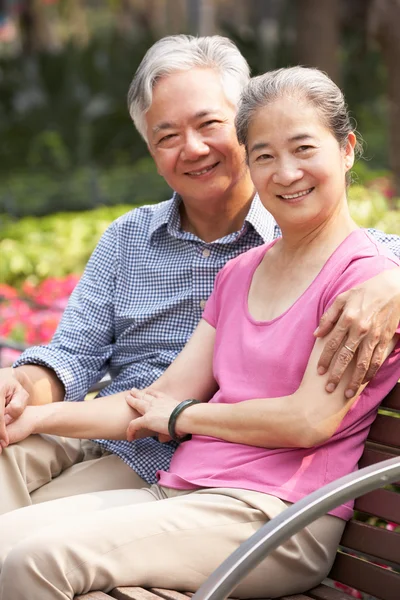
left=314, top=268, right=400, bottom=398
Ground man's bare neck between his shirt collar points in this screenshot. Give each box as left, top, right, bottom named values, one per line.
left=181, top=184, right=255, bottom=243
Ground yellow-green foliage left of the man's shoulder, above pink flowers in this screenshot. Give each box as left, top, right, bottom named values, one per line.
left=0, top=206, right=133, bottom=287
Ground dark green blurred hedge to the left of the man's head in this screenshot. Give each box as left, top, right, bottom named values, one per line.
left=0, top=32, right=153, bottom=173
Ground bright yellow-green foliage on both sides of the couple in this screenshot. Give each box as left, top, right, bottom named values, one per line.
left=0, top=182, right=400, bottom=287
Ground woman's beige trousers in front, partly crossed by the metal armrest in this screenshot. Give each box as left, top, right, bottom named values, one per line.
left=0, top=485, right=344, bottom=600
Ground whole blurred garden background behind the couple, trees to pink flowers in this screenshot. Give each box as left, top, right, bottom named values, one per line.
left=0, top=0, right=400, bottom=364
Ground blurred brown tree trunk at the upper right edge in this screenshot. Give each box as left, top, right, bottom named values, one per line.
left=369, top=0, right=400, bottom=197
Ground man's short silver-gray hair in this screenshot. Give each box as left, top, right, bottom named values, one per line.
left=128, top=34, right=250, bottom=141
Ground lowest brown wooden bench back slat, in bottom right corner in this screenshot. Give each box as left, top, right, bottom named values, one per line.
left=329, top=552, right=400, bottom=600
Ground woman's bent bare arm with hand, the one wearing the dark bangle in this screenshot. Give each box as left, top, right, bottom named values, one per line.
left=128, top=336, right=398, bottom=448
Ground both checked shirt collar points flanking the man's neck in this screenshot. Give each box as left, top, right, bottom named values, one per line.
left=149, top=192, right=279, bottom=242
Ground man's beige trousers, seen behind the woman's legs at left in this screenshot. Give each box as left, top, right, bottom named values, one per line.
left=0, top=435, right=147, bottom=515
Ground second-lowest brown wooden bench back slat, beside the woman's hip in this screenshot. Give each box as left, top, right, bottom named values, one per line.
left=340, top=521, right=400, bottom=564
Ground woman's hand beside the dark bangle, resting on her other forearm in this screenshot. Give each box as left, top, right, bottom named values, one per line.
left=125, top=388, right=180, bottom=442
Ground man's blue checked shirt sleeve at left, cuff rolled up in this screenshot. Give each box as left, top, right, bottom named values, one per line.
left=13, top=222, right=119, bottom=401
